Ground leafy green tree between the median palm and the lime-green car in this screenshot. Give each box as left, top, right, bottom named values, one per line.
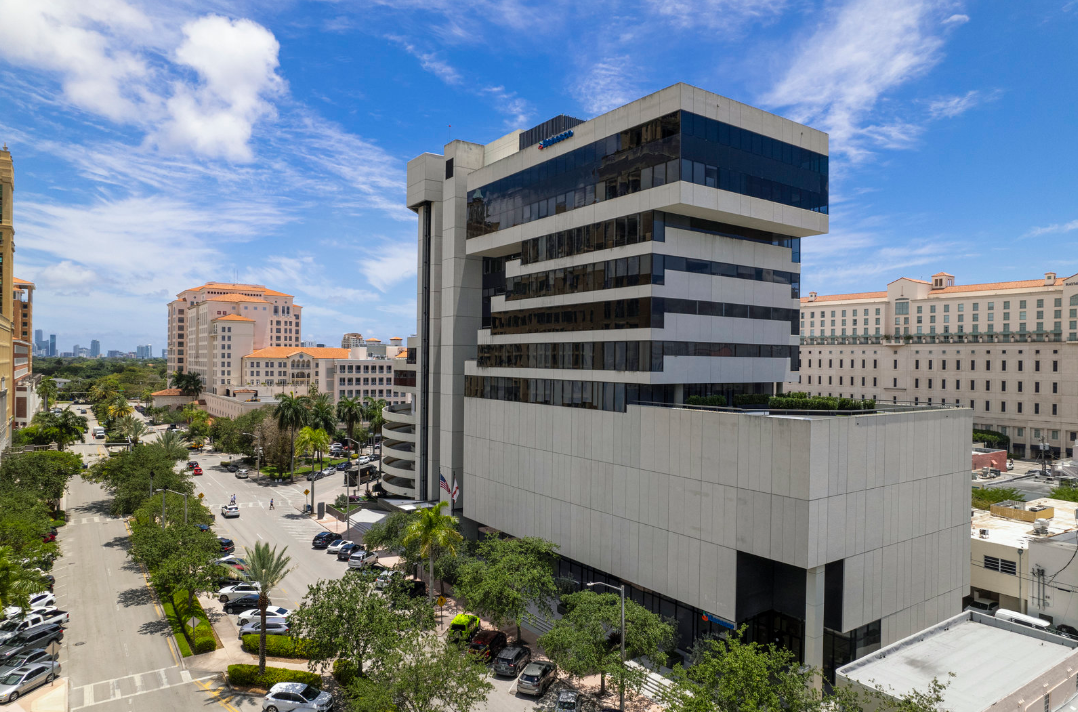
left=289, top=569, right=434, bottom=675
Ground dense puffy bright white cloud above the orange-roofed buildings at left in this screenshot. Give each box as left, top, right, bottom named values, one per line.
left=153, top=15, right=284, bottom=161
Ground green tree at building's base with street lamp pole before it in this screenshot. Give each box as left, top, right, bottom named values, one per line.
left=539, top=590, right=675, bottom=695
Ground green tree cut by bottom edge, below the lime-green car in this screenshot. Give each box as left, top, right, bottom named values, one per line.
left=348, top=630, right=494, bottom=712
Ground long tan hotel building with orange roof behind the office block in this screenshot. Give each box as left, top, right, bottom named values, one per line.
left=785, top=272, right=1078, bottom=457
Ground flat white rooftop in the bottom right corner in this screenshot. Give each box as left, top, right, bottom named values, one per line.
left=838, top=613, right=1078, bottom=712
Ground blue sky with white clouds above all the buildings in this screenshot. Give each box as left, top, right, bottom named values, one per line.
left=0, top=0, right=1078, bottom=350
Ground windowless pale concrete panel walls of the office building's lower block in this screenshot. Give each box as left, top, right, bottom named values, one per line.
left=465, top=398, right=970, bottom=644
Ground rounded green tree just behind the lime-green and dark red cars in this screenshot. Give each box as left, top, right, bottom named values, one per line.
left=454, top=536, right=558, bottom=640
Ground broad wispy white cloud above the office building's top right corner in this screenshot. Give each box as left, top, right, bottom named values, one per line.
left=761, top=0, right=956, bottom=161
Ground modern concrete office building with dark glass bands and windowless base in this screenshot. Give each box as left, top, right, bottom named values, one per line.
left=405, top=84, right=970, bottom=675
